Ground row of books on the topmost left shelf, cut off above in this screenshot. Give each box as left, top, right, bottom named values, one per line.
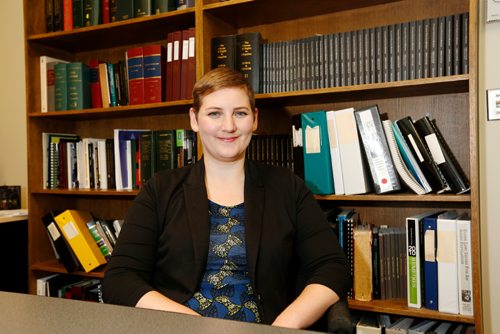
left=45, top=0, right=194, bottom=32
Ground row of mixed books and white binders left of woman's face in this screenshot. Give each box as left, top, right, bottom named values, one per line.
left=42, top=129, right=197, bottom=190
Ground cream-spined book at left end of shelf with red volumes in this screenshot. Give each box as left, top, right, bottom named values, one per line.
left=40, top=56, right=68, bottom=112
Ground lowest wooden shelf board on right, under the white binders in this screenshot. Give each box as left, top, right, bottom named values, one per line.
left=349, top=299, right=474, bottom=324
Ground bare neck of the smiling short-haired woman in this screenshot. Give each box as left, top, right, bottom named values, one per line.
left=204, top=159, right=245, bottom=206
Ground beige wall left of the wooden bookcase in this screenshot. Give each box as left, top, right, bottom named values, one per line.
left=0, top=0, right=28, bottom=208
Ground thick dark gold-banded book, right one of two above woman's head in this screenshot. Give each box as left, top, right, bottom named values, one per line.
left=236, top=32, right=262, bottom=93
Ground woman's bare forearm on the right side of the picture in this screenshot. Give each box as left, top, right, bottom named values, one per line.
left=273, top=284, right=339, bottom=329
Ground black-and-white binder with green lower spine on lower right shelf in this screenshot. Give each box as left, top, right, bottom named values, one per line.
left=405, top=212, right=435, bottom=308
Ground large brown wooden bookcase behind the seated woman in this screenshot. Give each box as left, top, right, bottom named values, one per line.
left=24, top=0, right=482, bottom=332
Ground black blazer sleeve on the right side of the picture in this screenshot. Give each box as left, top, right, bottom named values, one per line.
left=295, top=177, right=352, bottom=298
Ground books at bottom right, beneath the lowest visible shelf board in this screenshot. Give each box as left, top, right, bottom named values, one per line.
left=355, top=312, right=475, bottom=334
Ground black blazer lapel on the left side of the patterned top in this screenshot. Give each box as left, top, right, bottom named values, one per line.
left=183, top=161, right=210, bottom=277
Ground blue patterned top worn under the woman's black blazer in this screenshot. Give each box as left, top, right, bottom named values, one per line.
left=186, top=201, right=260, bottom=322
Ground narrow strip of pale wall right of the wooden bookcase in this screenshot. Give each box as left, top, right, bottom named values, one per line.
left=478, top=0, right=500, bottom=333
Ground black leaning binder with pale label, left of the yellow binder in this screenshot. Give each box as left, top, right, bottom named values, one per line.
left=42, top=211, right=80, bottom=273
